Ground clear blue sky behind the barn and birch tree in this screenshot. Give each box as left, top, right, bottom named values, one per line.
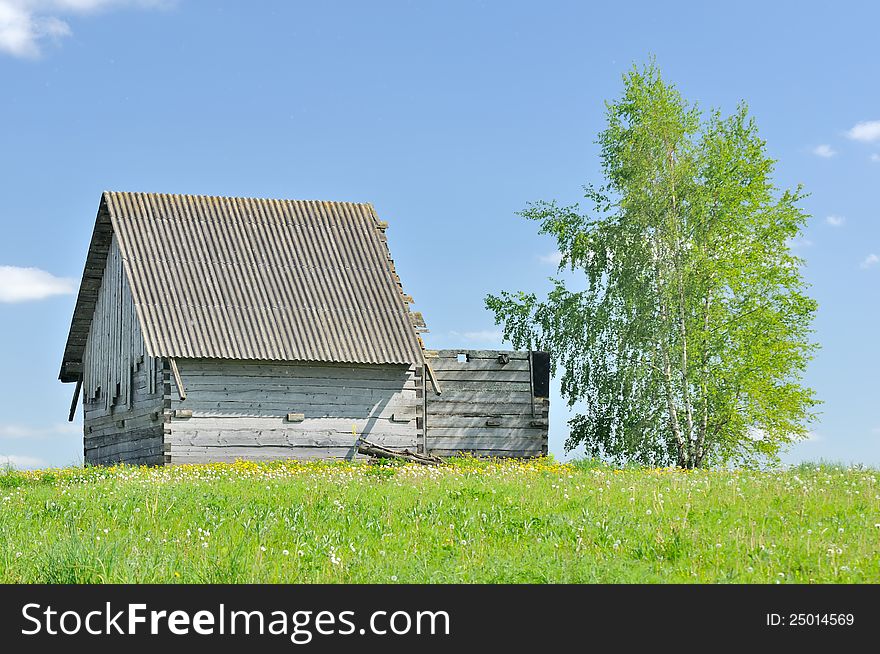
left=0, top=0, right=880, bottom=467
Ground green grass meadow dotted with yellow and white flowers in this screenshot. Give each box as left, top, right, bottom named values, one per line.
left=0, top=459, right=880, bottom=583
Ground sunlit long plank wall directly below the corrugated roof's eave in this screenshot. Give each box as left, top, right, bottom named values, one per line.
left=165, top=359, right=422, bottom=463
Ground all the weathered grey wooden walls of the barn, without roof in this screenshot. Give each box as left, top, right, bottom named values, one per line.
left=77, top=260, right=549, bottom=465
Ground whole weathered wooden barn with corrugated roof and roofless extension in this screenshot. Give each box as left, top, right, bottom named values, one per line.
left=60, top=192, right=549, bottom=464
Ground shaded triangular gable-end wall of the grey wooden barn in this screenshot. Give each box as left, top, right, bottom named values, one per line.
left=83, top=237, right=164, bottom=464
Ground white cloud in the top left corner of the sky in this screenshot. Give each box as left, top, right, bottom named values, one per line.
left=0, top=0, right=171, bottom=59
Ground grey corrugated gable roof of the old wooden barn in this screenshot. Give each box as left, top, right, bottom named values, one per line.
left=59, top=192, right=422, bottom=381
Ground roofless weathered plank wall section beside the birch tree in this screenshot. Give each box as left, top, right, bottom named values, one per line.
left=424, top=350, right=550, bottom=457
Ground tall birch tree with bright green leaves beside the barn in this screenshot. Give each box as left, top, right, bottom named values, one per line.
left=486, top=63, right=817, bottom=468
